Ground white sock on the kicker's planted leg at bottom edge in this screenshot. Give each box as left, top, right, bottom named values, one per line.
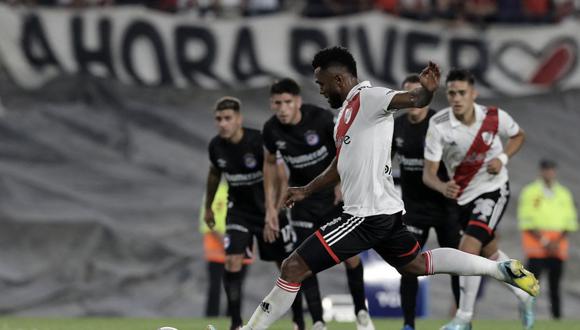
left=242, top=278, right=300, bottom=330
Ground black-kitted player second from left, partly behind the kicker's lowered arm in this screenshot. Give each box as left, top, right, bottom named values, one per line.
left=262, top=78, right=374, bottom=330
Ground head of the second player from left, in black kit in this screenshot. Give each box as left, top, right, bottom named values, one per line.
left=270, top=78, right=302, bottom=125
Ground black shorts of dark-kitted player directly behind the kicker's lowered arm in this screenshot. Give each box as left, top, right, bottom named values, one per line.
left=287, top=200, right=343, bottom=244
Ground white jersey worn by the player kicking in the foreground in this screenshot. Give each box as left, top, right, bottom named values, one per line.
left=334, top=81, right=404, bottom=217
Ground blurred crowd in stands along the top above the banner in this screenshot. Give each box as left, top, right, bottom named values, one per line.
left=0, top=0, right=580, bottom=24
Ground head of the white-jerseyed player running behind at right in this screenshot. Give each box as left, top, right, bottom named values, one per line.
left=445, top=69, right=478, bottom=116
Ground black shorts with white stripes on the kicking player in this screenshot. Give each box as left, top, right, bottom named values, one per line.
left=296, top=212, right=421, bottom=273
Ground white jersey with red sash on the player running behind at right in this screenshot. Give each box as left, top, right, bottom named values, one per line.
left=424, top=104, right=520, bottom=205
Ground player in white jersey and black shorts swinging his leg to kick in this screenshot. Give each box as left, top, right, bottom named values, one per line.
left=207, top=47, right=539, bottom=330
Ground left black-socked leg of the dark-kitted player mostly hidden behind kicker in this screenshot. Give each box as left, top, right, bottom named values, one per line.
left=399, top=224, right=430, bottom=330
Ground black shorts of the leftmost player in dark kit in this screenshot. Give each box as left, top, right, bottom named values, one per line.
left=224, top=214, right=296, bottom=261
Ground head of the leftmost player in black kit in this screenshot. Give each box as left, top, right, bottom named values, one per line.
left=214, top=96, right=242, bottom=140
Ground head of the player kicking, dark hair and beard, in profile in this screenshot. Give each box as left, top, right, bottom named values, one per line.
left=312, top=46, right=358, bottom=108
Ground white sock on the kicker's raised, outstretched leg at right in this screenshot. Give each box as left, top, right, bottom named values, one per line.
left=423, top=248, right=504, bottom=281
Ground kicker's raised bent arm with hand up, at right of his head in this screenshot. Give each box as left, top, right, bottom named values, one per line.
left=388, top=61, right=441, bottom=110
